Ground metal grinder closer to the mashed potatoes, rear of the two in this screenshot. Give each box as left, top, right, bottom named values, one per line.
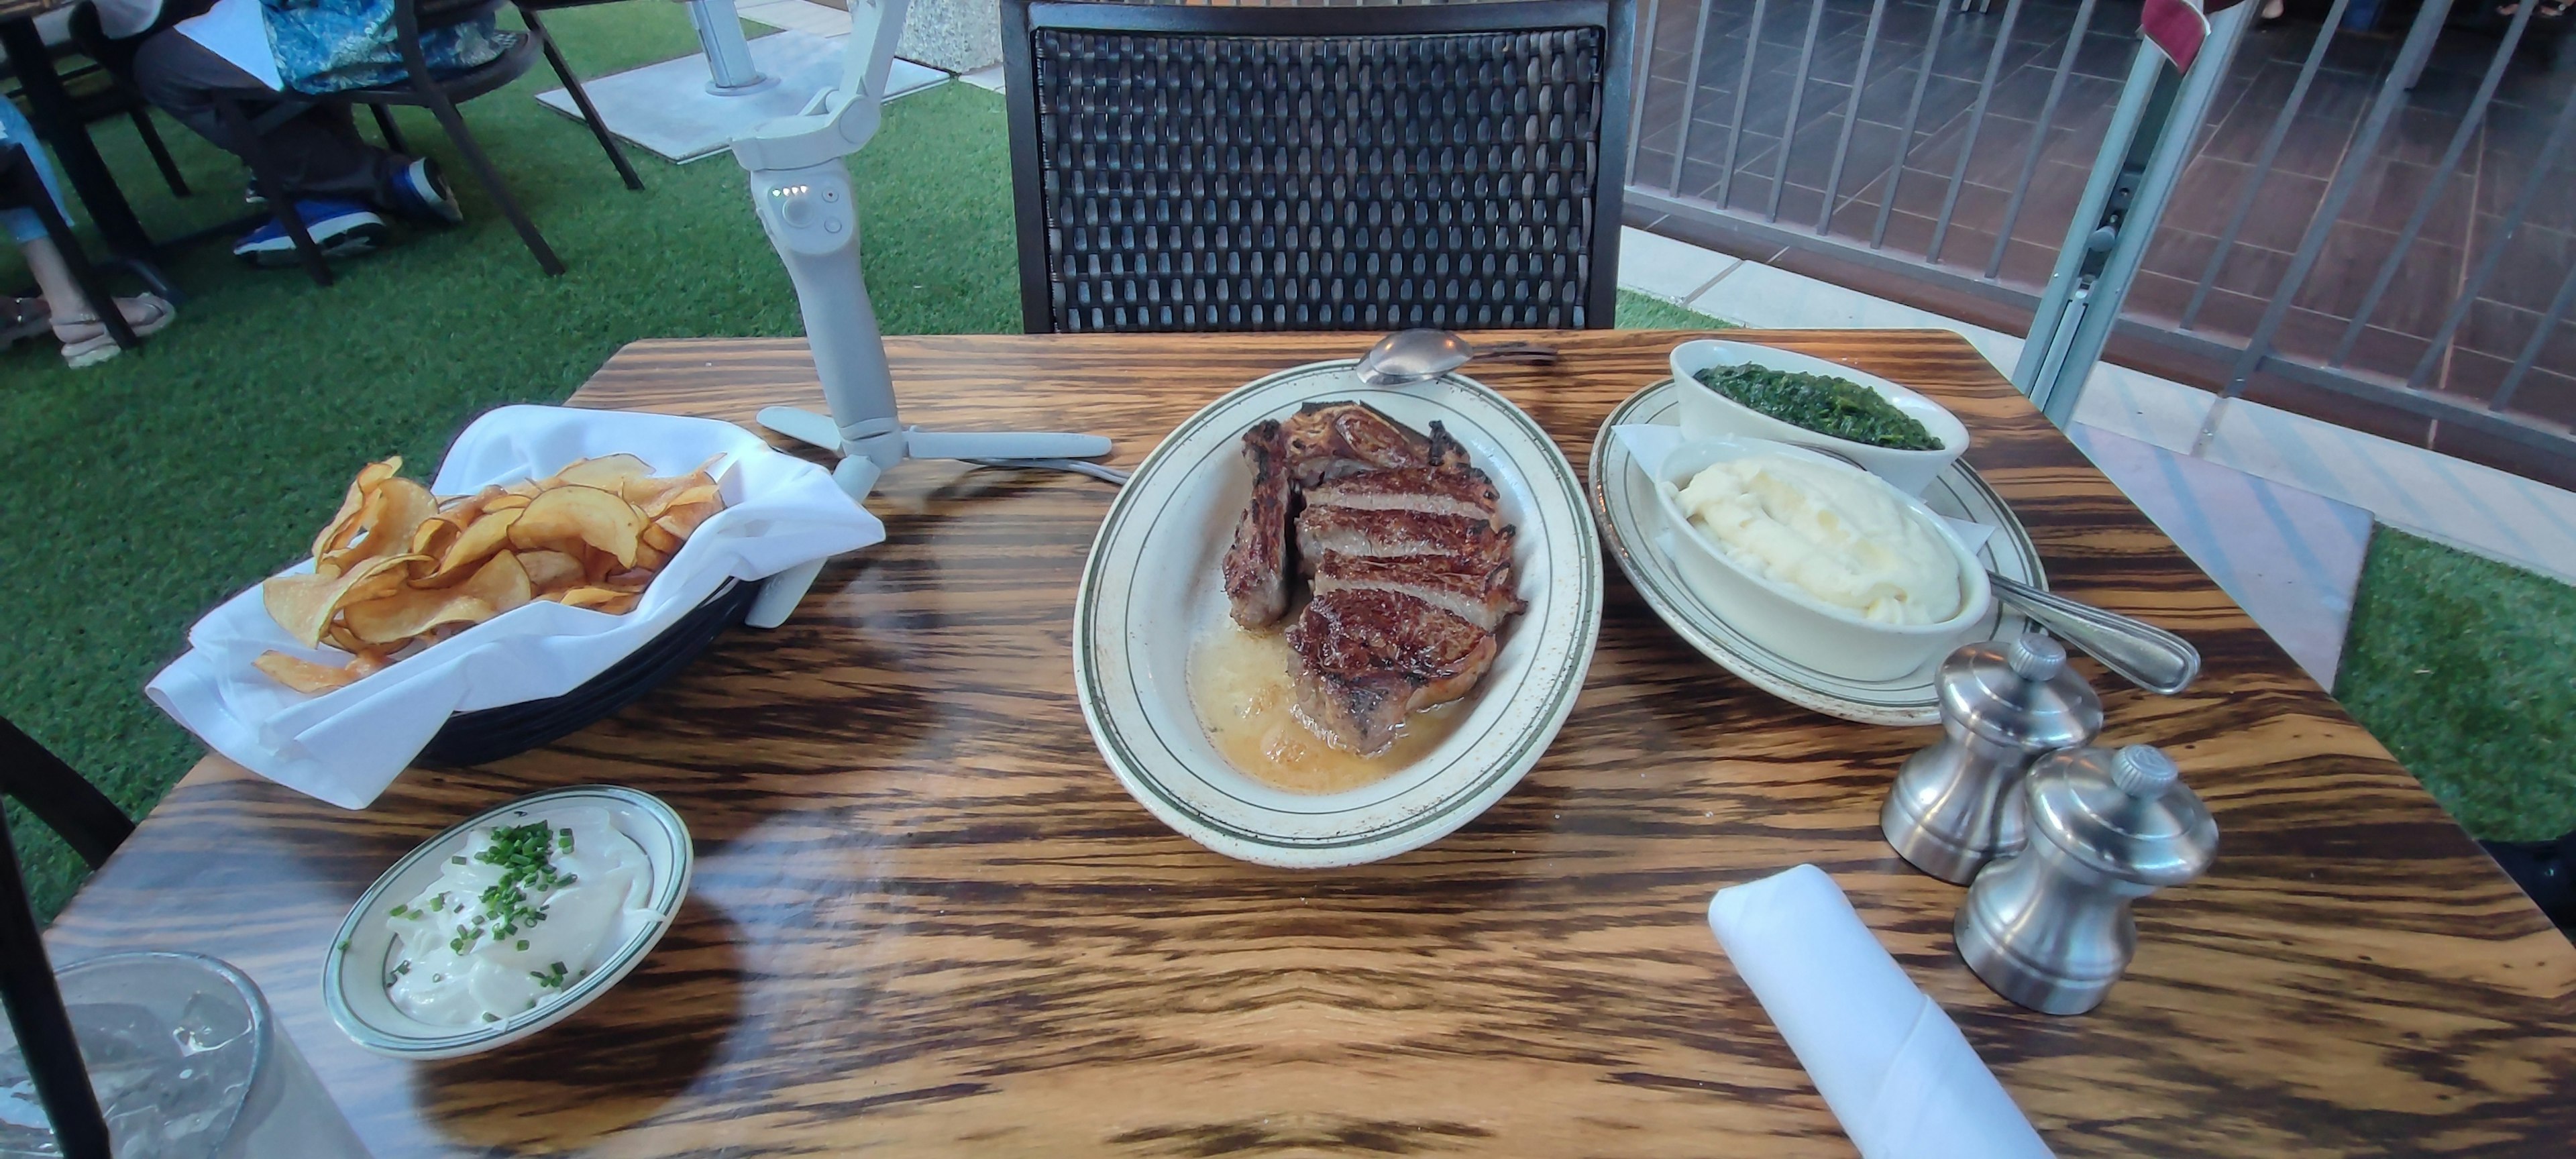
left=1878, top=634, right=2102, bottom=886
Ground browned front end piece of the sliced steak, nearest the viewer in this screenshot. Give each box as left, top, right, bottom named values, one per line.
left=1288, top=590, right=1497, bottom=755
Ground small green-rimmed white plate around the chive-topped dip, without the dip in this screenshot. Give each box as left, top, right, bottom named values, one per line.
left=322, top=785, right=696, bottom=1058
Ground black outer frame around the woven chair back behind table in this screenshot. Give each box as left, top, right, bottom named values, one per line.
left=1002, top=0, right=1635, bottom=335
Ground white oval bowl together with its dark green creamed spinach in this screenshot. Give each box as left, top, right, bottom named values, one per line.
left=1672, top=337, right=1968, bottom=494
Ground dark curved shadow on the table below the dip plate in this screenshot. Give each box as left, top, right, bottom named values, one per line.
left=412, top=899, right=742, bottom=1154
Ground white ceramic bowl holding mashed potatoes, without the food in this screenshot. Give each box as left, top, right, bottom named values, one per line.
left=1654, top=438, right=1994, bottom=680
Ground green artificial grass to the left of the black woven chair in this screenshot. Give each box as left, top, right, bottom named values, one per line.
left=0, top=3, right=1018, bottom=914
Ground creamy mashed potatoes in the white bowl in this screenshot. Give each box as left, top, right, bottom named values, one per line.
left=1677, top=456, right=1966, bottom=623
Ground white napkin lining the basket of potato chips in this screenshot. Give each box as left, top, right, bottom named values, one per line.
left=144, top=407, right=886, bottom=809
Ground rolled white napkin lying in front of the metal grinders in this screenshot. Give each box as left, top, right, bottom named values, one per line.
left=1708, top=865, right=2051, bottom=1159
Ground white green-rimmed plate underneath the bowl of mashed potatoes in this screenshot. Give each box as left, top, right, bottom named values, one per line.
left=1592, top=378, right=2048, bottom=724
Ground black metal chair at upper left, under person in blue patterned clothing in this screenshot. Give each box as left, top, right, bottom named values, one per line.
left=217, top=0, right=644, bottom=286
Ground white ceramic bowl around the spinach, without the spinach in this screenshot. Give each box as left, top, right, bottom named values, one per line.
left=1672, top=337, right=1968, bottom=494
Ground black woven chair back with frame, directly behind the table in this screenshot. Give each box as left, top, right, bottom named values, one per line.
left=1002, top=0, right=1635, bottom=332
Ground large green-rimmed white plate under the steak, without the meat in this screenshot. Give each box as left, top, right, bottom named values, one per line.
left=1074, top=361, right=1602, bottom=868
